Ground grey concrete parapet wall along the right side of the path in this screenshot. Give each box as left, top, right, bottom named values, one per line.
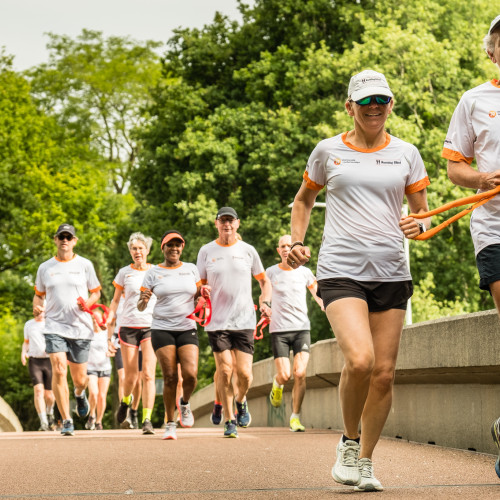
left=191, top=310, right=500, bottom=453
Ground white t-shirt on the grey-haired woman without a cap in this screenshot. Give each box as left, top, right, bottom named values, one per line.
left=113, top=264, right=156, bottom=328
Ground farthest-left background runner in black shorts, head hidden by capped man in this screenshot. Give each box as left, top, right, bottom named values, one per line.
left=21, top=313, right=56, bottom=431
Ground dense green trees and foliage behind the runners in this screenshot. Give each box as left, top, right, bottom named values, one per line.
left=0, top=0, right=498, bottom=427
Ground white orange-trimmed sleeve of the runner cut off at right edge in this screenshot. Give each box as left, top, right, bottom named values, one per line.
left=441, top=94, right=475, bottom=164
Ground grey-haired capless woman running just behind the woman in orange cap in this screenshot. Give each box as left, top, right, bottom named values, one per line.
left=107, top=233, right=156, bottom=434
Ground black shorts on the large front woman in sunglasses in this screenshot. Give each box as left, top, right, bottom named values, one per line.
left=318, top=278, right=413, bottom=312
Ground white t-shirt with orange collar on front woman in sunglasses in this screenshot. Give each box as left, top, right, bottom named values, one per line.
left=304, top=132, right=429, bottom=282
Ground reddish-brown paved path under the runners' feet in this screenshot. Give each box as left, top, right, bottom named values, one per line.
left=0, top=427, right=500, bottom=500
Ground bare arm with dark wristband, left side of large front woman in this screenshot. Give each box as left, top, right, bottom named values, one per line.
left=287, top=181, right=319, bottom=267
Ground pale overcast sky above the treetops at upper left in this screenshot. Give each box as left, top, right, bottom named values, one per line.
left=0, top=0, right=254, bottom=70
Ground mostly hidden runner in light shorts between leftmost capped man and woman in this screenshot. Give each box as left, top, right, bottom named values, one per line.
left=85, top=312, right=111, bottom=431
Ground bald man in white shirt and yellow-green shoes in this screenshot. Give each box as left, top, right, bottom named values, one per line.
left=266, top=234, right=323, bottom=432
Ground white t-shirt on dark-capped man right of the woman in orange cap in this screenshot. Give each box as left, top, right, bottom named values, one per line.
left=196, top=240, right=265, bottom=332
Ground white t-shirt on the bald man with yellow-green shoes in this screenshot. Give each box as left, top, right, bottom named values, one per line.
left=266, top=264, right=316, bottom=333
